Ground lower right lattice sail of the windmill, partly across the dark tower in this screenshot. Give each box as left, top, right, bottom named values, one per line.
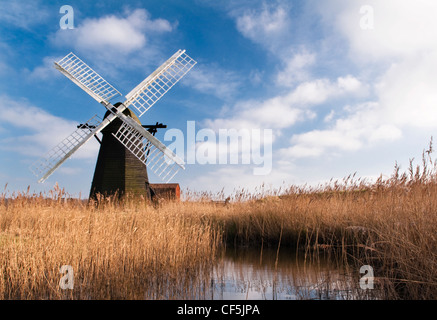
left=113, top=117, right=185, bottom=182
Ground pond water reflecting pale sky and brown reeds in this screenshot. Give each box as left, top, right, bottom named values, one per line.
left=205, top=249, right=371, bottom=300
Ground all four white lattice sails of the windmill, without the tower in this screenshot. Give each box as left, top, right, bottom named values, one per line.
left=30, top=50, right=192, bottom=182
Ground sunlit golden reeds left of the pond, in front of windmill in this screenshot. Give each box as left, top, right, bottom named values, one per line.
left=0, top=189, right=219, bottom=299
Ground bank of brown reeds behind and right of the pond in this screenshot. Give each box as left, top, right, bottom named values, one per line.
left=178, top=144, right=437, bottom=299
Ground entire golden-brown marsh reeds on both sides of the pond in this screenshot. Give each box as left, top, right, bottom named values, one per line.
left=0, top=143, right=437, bottom=299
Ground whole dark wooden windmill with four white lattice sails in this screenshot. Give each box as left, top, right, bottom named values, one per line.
left=30, top=50, right=196, bottom=197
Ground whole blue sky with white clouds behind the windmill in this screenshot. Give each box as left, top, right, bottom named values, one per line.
left=0, top=0, right=437, bottom=197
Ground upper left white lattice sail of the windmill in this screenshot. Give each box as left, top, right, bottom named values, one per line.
left=55, top=52, right=121, bottom=105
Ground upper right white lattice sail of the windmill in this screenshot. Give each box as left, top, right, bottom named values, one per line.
left=124, top=50, right=196, bottom=117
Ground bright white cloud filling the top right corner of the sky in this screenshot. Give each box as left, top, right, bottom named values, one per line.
left=326, top=0, right=437, bottom=61
